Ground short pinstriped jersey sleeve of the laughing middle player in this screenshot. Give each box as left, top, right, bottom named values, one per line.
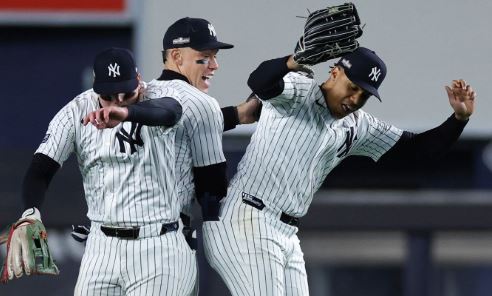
left=182, top=100, right=225, bottom=167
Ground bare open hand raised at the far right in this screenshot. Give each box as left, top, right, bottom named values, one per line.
left=445, top=79, right=477, bottom=121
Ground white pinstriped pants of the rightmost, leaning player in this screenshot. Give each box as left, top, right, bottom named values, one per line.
left=203, top=192, right=309, bottom=296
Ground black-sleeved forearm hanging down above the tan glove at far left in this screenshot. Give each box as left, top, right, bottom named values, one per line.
left=21, top=153, right=60, bottom=209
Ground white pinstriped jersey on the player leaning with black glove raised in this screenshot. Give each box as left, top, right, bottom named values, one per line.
left=230, top=72, right=403, bottom=217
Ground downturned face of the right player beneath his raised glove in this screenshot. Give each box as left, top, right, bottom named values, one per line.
left=321, top=66, right=369, bottom=119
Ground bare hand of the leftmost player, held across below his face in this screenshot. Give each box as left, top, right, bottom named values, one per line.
left=82, top=106, right=128, bottom=129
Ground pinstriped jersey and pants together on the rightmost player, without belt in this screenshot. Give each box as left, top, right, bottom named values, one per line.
left=203, top=73, right=402, bottom=296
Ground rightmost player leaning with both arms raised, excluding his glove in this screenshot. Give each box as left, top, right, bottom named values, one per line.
left=203, top=47, right=475, bottom=295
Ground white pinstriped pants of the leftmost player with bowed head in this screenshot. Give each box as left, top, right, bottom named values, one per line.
left=74, top=223, right=198, bottom=296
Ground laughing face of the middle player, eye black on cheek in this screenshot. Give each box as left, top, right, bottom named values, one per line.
left=169, top=47, right=219, bottom=93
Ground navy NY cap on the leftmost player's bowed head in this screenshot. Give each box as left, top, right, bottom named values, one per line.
left=93, top=47, right=138, bottom=95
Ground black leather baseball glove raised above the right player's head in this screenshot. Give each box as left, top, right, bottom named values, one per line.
left=294, top=3, right=362, bottom=66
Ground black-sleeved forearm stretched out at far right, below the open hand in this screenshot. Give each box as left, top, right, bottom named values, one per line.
left=384, top=114, right=468, bottom=160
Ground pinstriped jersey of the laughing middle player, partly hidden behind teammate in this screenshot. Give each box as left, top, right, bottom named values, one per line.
left=146, top=79, right=225, bottom=214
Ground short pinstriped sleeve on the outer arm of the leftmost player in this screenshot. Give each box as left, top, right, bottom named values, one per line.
left=36, top=105, right=75, bottom=166
